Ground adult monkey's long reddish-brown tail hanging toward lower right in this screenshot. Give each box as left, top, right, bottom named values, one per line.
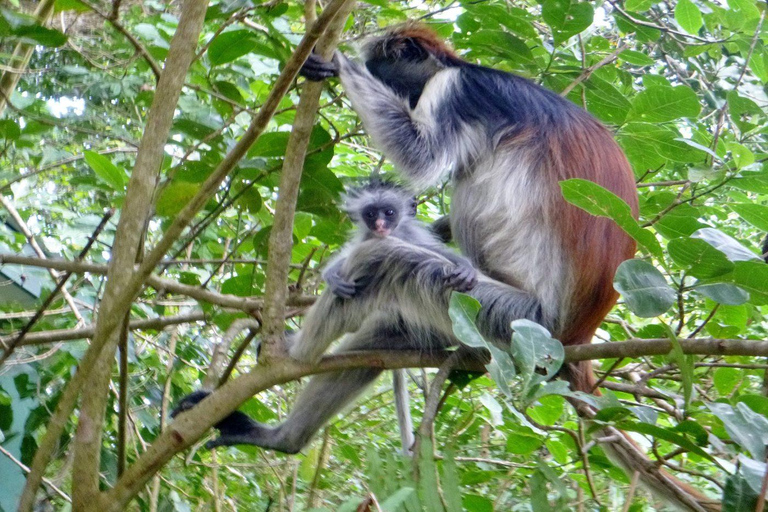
left=564, top=361, right=722, bottom=512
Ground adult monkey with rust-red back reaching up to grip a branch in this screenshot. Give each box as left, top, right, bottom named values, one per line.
left=302, top=25, right=720, bottom=510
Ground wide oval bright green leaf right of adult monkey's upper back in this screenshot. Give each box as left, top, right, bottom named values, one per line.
left=629, top=85, right=701, bottom=123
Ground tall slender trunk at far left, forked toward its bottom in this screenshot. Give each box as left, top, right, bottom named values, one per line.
left=19, top=0, right=207, bottom=506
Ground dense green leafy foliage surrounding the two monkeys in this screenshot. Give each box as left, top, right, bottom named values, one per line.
left=0, top=0, right=768, bottom=511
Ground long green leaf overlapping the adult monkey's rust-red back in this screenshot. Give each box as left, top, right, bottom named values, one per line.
left=560, top=178, right=662, bottom=258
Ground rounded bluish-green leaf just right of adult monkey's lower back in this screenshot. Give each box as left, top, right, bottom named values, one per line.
left=613, top=260, right=677, bottom=318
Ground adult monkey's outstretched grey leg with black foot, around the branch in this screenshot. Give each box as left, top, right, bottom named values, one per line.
left=208, top=317, right=452, bottom=453
